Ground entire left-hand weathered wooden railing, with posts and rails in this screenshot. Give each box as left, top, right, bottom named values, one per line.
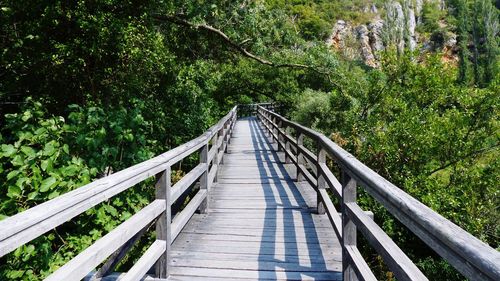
left=0, top=107, right=237, bottom=281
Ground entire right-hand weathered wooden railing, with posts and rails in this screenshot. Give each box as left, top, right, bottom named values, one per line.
left=258, top=106, right=500, bottom=281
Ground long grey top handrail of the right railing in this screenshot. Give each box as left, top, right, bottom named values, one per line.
left=261, top=105, right=500, bottom=280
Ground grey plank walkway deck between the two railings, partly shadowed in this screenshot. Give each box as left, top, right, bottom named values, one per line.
left=169, top=118, right=342, bottom=280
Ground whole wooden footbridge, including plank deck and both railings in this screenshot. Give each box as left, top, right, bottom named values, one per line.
left=0, top=104, right=500, bottom=281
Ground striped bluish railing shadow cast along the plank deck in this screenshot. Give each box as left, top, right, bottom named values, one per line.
left=244, top=118, right=334, bottom=279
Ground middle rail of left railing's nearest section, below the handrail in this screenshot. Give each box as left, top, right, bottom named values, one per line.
left=45, top=200, right=165, bottom=281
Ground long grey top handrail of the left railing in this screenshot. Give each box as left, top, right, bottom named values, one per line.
left=0, top=107, right=236, bottom=257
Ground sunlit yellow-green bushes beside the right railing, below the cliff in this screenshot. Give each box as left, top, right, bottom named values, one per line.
left=293, top=54, right=500, bottom=280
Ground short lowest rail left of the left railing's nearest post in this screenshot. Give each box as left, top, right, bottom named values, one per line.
left=120, top=240, right=167, bottom=281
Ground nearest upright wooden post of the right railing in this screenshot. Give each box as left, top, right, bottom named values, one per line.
left=342, top=171, right=357, bottom=281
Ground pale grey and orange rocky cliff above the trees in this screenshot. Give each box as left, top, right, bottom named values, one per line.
left=327, top=0, right=456, bottom=67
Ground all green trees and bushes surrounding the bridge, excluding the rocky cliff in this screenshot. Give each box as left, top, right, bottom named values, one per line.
left=0, top=0, right=500, bottom=280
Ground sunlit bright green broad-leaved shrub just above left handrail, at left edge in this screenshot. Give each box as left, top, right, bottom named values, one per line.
left=0, top=98, right=96, bottom=212
